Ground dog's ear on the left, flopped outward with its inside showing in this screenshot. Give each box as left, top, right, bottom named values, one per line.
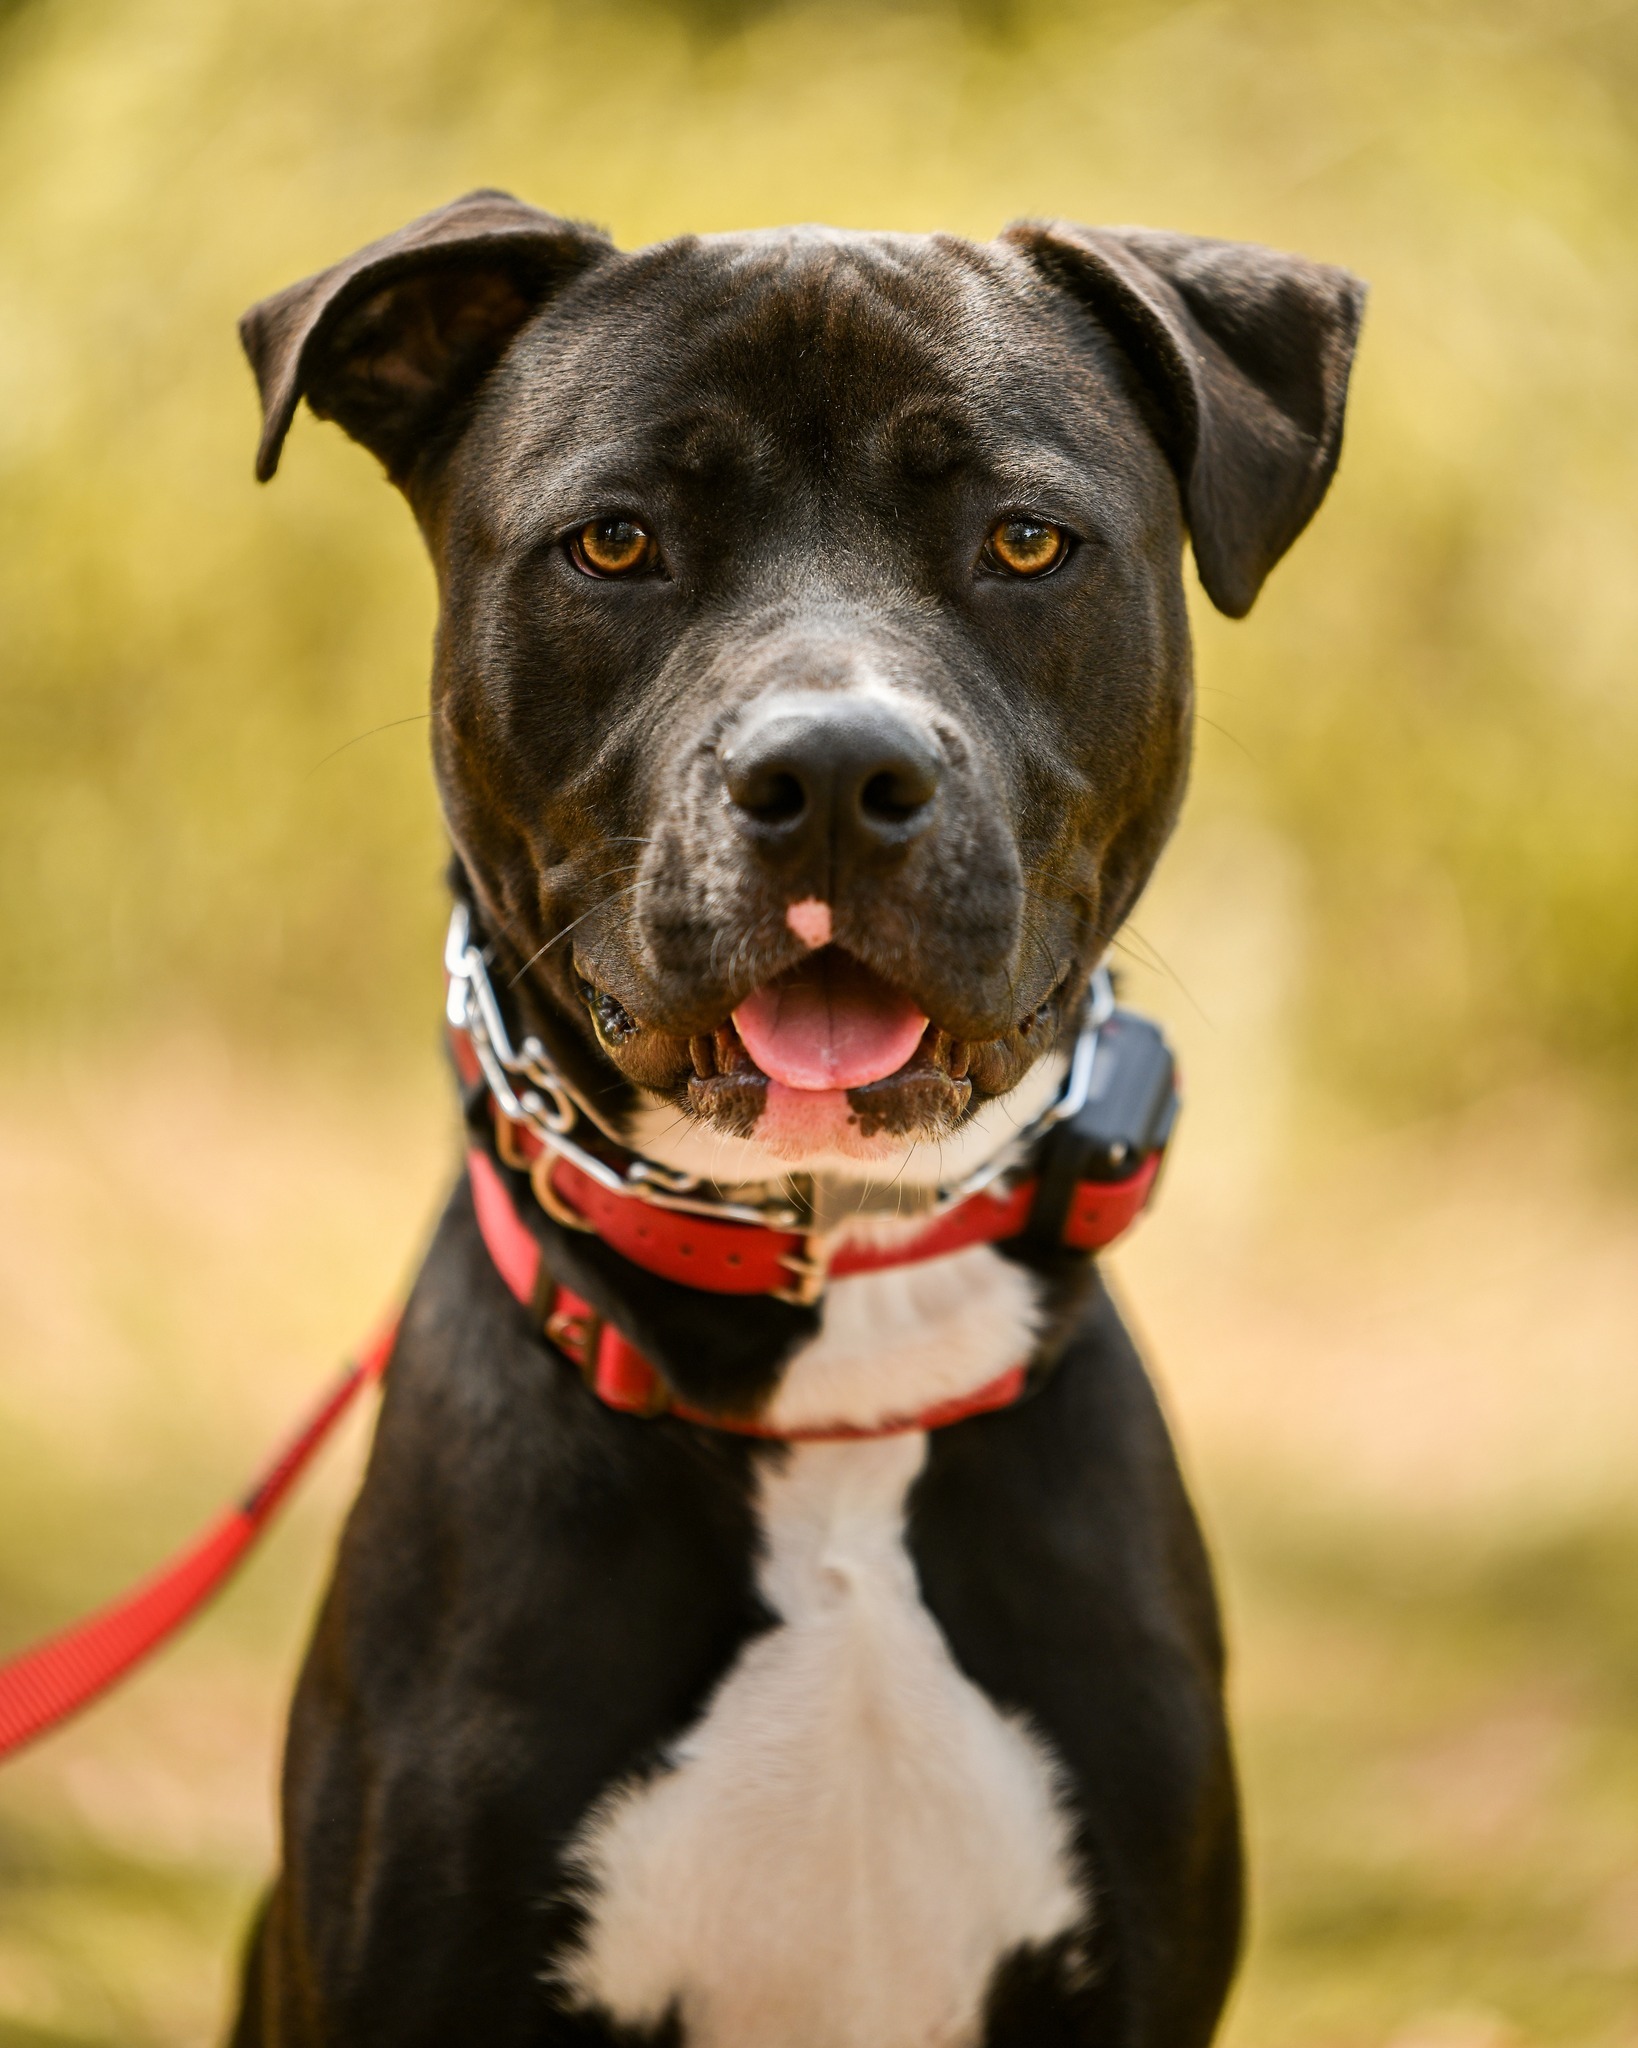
left=240, top=193, right=612, bottom=483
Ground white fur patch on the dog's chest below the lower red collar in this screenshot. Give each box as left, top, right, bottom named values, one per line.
left=563, top=1436, right=1087, bottom=2048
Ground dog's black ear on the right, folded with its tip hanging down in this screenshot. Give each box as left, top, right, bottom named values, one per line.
left=1001, top=221, right=1366, bottom=618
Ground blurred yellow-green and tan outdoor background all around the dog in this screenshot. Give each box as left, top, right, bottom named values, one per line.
left=0, top=0, right=1638, bottom=2048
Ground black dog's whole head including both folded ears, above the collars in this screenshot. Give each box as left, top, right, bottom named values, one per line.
left=244, top=193, right=1364, bottom=1178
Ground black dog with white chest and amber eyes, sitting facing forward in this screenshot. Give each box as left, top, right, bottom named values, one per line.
left=235, top=193, right=1362, bottom=2048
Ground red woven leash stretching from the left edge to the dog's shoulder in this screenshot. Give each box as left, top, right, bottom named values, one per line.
left=0, top=1313, right=397, bottom=1761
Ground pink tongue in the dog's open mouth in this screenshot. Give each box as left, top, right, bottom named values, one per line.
left=733, top=956, right=928, bottom=1087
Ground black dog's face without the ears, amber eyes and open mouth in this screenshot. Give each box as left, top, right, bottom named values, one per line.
left=442, top=233, right=1190, bottom=1149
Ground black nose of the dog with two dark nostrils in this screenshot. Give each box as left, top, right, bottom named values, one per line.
left=721, top=690, right=940, bottom=868
